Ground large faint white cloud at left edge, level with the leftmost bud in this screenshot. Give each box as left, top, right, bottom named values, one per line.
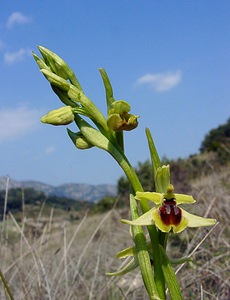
left=0, top=106, right=41, bottom=142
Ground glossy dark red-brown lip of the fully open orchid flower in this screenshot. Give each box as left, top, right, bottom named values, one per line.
left=160, top=199, right=181, bottom=226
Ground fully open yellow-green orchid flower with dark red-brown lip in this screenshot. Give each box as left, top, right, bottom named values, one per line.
left=122, top=184, right=216, bottom=233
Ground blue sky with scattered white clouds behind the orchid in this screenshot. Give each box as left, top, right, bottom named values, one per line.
left=0, top=0, right=230, bottom=185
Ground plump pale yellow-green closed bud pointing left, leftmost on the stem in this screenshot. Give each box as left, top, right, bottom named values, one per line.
left=41, top=106, right=74, bottom=125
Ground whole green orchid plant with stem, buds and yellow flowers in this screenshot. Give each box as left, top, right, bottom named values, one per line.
left=33, top=46, right=216, bottom=300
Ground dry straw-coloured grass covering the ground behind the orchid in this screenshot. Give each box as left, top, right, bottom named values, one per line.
left=0, top=170, right=230, bottom=300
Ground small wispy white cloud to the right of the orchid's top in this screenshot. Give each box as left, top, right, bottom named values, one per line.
left=136, top=70, right=182, bottom=92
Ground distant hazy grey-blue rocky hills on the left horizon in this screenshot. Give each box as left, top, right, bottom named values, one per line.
left=0, top=176, right=117, bottom=203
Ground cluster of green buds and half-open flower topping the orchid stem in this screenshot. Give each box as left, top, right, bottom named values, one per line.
left=33, top=46, right=138, bottom=152
